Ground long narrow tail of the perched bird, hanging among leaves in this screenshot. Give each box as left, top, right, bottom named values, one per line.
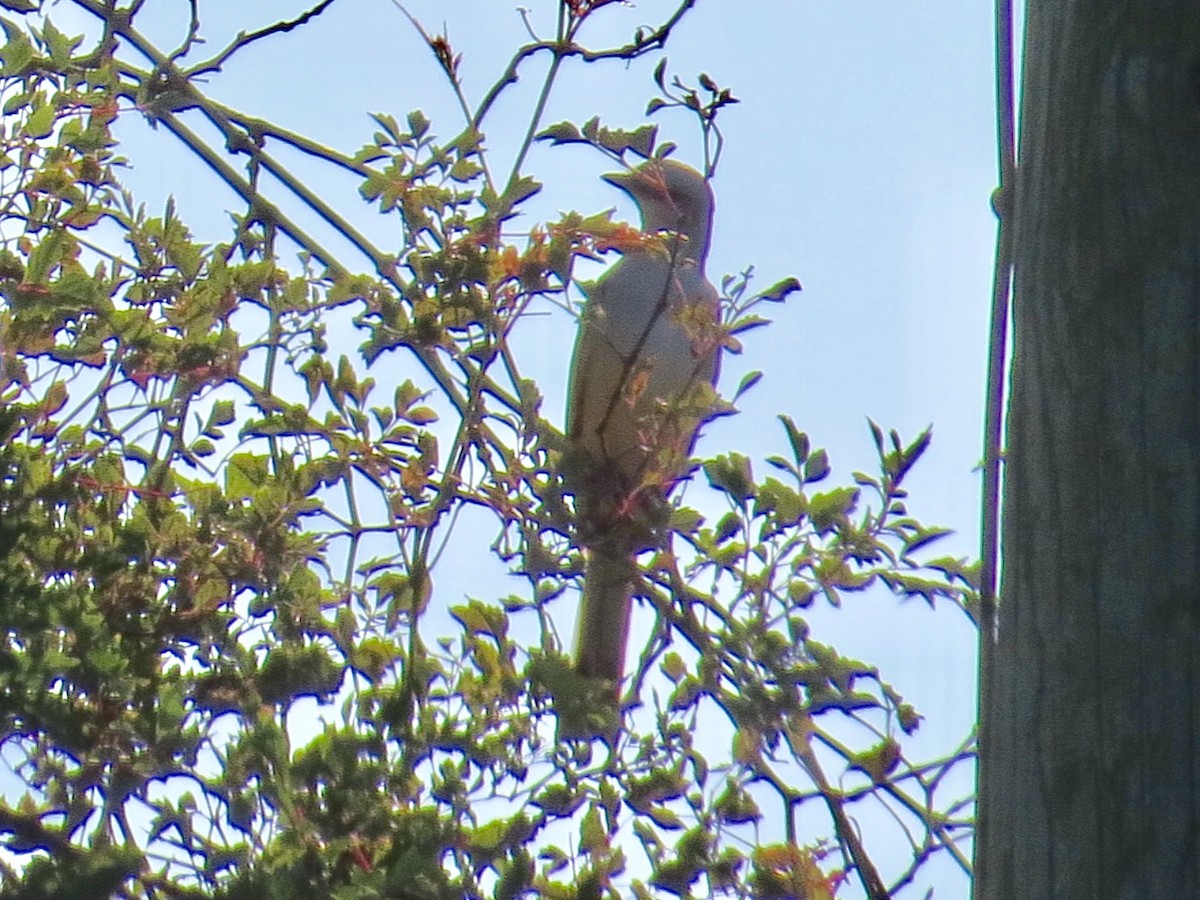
left=575, top=546, right=636, bottom=685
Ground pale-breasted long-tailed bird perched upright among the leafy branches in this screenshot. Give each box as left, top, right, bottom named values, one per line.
left=564, top=158, right=722, bottom=692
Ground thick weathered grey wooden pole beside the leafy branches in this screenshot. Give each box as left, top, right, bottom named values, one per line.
left=974, top=7, right=1200, bottom=900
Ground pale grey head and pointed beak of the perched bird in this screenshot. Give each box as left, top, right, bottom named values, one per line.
left=604, top=160, right=714, bottom=262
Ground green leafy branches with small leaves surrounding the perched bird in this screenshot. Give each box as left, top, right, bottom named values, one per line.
left=0, top=0, right=973, bottom=900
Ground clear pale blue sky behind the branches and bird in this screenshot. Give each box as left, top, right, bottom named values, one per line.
left=23, top=0, right=996, bottom=898
